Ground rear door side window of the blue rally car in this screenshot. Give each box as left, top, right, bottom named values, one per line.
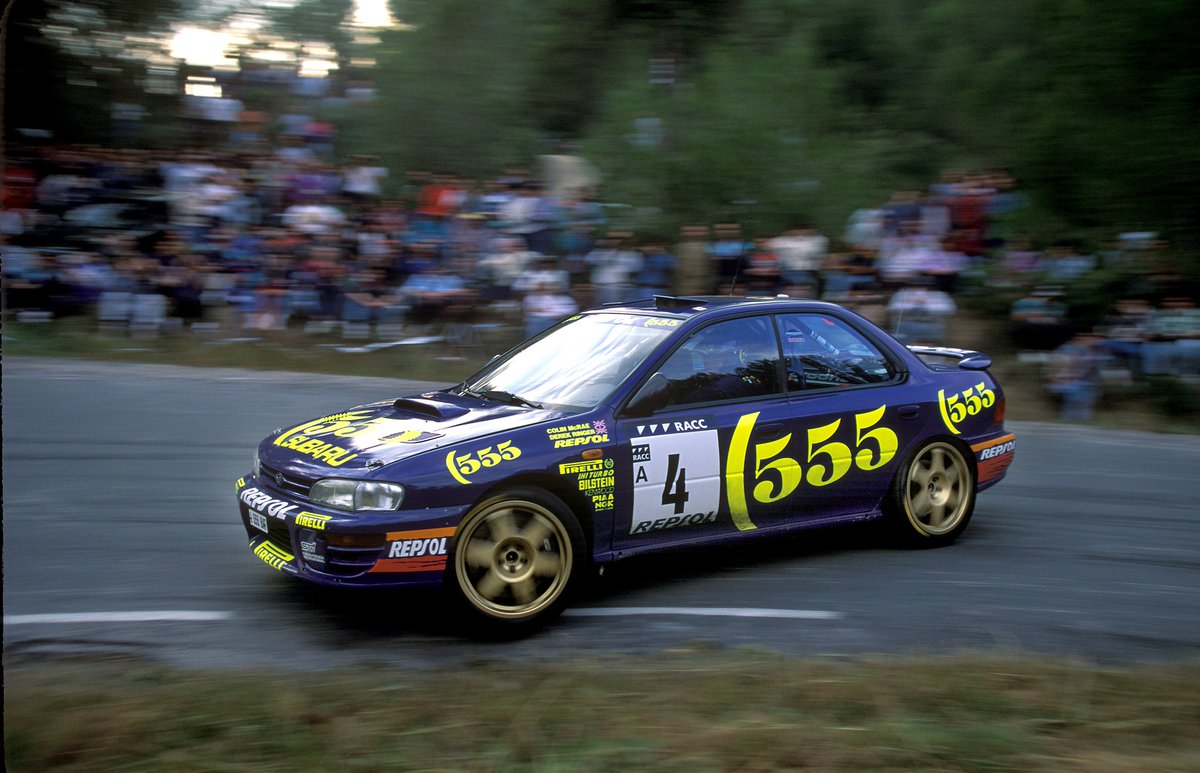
left=779, top=313, right=896, bottom=393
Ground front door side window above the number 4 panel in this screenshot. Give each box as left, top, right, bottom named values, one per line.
left=659, top=317, right=779, bottom=407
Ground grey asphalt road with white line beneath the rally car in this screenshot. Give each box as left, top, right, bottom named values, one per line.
left=2, top=358, right=1200, bottom=669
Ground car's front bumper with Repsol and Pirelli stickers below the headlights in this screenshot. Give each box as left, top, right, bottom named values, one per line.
left=235, top=475, right=463, bottom=587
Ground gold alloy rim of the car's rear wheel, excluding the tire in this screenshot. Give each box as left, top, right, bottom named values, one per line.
left=904, top=442, right=973, bottom=537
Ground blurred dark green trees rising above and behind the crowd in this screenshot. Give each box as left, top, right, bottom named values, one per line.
left=7, top=0, right=1200, bottom=248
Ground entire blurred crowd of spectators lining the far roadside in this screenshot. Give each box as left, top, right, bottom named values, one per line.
left=0, top=128, right=1200, bottom=418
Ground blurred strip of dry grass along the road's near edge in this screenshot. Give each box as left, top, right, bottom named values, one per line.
left=5, top=648, right=1200, bottom=773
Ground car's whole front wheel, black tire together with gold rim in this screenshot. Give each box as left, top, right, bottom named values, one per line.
left=446, top=489, right=587, bottom=633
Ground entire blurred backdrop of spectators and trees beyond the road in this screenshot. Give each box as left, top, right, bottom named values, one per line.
left=0, top=0, right=1200, bottom=429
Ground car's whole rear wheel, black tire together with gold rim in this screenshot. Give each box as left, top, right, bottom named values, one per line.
left=889, top=441, right=976, bottom=547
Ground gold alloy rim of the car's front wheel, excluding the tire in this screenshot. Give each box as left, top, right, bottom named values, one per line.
left=455, top=497, right=574, bottom=621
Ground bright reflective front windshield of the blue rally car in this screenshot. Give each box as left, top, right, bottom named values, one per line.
left=464, top=313, right=679, bottom=408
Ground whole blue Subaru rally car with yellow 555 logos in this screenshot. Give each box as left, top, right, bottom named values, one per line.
left=236, top=298, right=1015, bottom=627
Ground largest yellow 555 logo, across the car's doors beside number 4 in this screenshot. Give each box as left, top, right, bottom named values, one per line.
left=725, top=406, right=900, bottom=532
